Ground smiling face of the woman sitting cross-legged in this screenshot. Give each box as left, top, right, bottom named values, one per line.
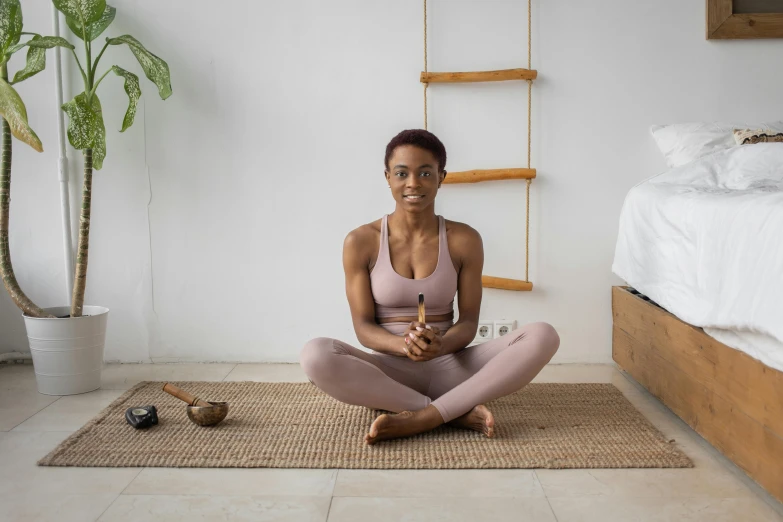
left=386, top=145, right=446, bottom=212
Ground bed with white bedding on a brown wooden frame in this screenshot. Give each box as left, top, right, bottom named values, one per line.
left=612, top=135, right=783, bottom=500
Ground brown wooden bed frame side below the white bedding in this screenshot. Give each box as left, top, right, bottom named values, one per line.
left=612, top=286, right=783, bottom=501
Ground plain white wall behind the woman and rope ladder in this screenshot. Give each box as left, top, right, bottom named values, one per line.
left=0, top=0, right=783, bottom=362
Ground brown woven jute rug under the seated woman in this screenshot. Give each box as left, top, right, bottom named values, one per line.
left=38, top=382, right=693, bottom=469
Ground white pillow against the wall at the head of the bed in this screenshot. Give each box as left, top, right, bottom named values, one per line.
left=650, top=121, right=783, bottom=168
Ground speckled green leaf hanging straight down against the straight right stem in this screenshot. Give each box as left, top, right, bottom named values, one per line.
left=62, top=93, right=106, bottom=170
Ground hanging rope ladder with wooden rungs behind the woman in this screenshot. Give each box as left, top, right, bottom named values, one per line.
left=419, top=0, right=538, bottom=291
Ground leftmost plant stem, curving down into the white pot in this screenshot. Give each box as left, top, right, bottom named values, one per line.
left=0, top=64, right=54, bottom=317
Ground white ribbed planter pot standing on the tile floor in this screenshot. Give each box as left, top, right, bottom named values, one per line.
left=24, top=306, right=109, bottom=395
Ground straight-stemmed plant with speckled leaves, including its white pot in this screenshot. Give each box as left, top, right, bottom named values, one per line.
left=0, top=0, right=172, bottom=395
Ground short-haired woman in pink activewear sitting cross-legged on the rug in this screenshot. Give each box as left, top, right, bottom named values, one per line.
left=300, top=130, right=560, bottom=444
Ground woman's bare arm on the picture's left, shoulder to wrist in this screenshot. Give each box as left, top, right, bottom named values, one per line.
left=343, top=225, right=404, bottom=357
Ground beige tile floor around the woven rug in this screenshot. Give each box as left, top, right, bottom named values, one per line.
left=0, top=364, right=783, bottom=522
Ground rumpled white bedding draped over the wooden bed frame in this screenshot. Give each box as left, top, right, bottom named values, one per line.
left=612, top=143, right=783, bottom=371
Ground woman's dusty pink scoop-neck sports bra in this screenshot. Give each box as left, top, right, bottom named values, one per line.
left=370, top=214, right=457, bottom=317
